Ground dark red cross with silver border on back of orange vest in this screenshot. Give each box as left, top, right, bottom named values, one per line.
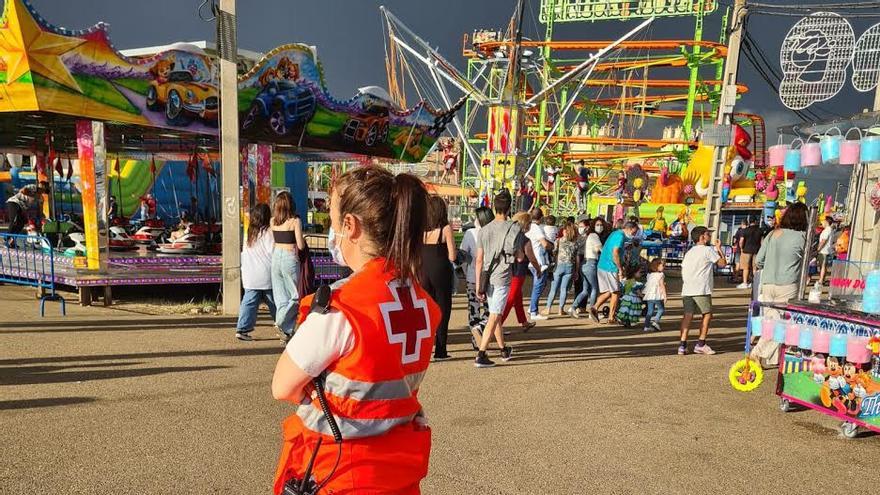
left=379, top=280, right=431, bottom=364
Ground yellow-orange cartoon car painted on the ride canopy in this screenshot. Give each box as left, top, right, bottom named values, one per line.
left=146, top=70, right=219, bottom=126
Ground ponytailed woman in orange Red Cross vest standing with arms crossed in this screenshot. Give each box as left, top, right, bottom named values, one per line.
left=272, top=167, right=440, bottom=495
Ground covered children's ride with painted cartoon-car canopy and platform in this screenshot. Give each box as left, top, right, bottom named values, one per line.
left=0, top=0, right=457, bottom=303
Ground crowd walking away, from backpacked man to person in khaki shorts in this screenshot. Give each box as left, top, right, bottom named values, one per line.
left=458, top=191, right=726, bottom=368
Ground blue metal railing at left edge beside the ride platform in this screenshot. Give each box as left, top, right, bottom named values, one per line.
left=0, top=234, right=67, bottom=316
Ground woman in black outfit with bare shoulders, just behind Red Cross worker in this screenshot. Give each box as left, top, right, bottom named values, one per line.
left=422, top=196, right=456, bottom=361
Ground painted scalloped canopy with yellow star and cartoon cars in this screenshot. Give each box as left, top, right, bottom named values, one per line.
left=0, top=0, right=454, bottom=162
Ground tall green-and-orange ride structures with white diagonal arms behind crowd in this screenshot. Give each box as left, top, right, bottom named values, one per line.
left=383, top=0, right=791, bottom=229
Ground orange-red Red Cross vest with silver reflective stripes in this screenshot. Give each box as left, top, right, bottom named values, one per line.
left=274, top=258, right=440, bottom=495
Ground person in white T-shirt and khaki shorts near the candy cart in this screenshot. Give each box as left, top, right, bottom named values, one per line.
left=678, top=227, right=727, bottom=355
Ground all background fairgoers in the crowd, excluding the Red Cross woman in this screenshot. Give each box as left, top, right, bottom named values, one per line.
left=236, top=181, right=835, bottom=368
